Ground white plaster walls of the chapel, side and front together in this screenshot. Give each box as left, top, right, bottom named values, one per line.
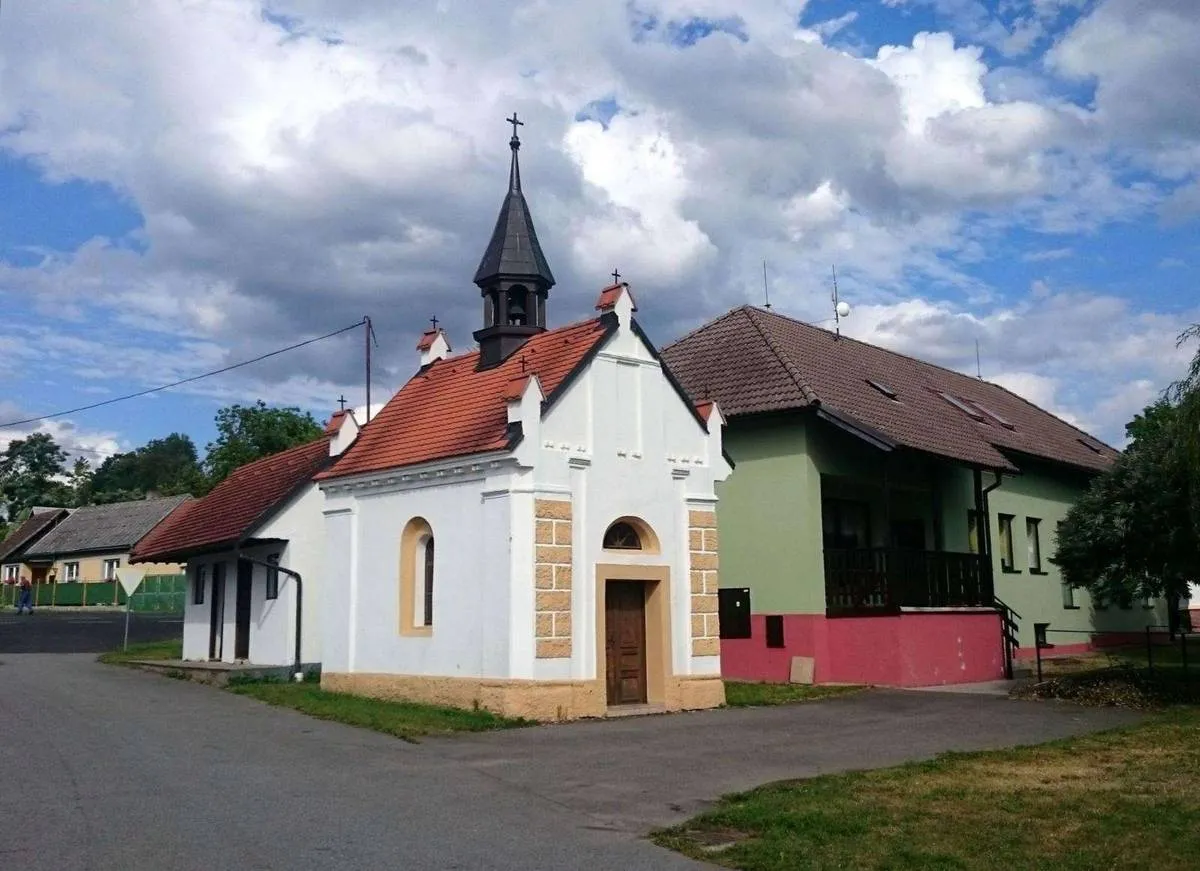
left=322, top=314, right=728, bottom=679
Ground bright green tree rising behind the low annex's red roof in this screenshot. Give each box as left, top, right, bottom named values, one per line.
left=204, top=400, right=322, bottom=486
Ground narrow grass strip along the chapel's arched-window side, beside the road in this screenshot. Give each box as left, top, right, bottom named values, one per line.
left=227, top=681, right=533, bottom=741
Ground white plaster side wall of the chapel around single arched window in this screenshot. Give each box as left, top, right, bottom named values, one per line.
left=325, top=474, right=513, bottom=677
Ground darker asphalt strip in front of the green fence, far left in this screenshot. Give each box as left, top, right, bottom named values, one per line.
left=0, top=608, right=184, bottom=654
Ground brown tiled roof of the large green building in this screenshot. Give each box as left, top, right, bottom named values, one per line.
left=662, top=306, right=1117, bottom=470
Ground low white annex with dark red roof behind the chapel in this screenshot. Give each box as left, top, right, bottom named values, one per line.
left=132, top=412, right=359, bottom=666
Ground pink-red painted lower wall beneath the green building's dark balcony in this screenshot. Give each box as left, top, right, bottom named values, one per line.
left=721, top=611, right=1004, bottom=686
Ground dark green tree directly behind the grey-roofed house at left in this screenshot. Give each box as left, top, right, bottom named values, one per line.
left=92, top=432, right=205, bottom=504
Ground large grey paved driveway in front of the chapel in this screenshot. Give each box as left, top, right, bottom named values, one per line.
left=0, top=655, right=1132, bottom=871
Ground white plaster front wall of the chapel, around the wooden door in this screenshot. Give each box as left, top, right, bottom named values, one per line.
left=534, top=325, right=730, bottom=679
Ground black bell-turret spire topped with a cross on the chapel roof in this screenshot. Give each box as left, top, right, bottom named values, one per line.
left=474, top=113, right=554, bottom=367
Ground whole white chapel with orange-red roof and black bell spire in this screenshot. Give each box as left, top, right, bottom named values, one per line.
left=317, top=122, right=731, bottom=720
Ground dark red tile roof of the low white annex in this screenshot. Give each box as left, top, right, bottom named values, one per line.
left=131, top=437, right=329, bottom=563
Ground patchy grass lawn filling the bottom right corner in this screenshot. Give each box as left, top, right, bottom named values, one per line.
left=654, top=708, right=1200, bottom=871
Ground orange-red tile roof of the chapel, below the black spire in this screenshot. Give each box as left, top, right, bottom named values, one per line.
left=317, top=314, right=616, bottom=479
